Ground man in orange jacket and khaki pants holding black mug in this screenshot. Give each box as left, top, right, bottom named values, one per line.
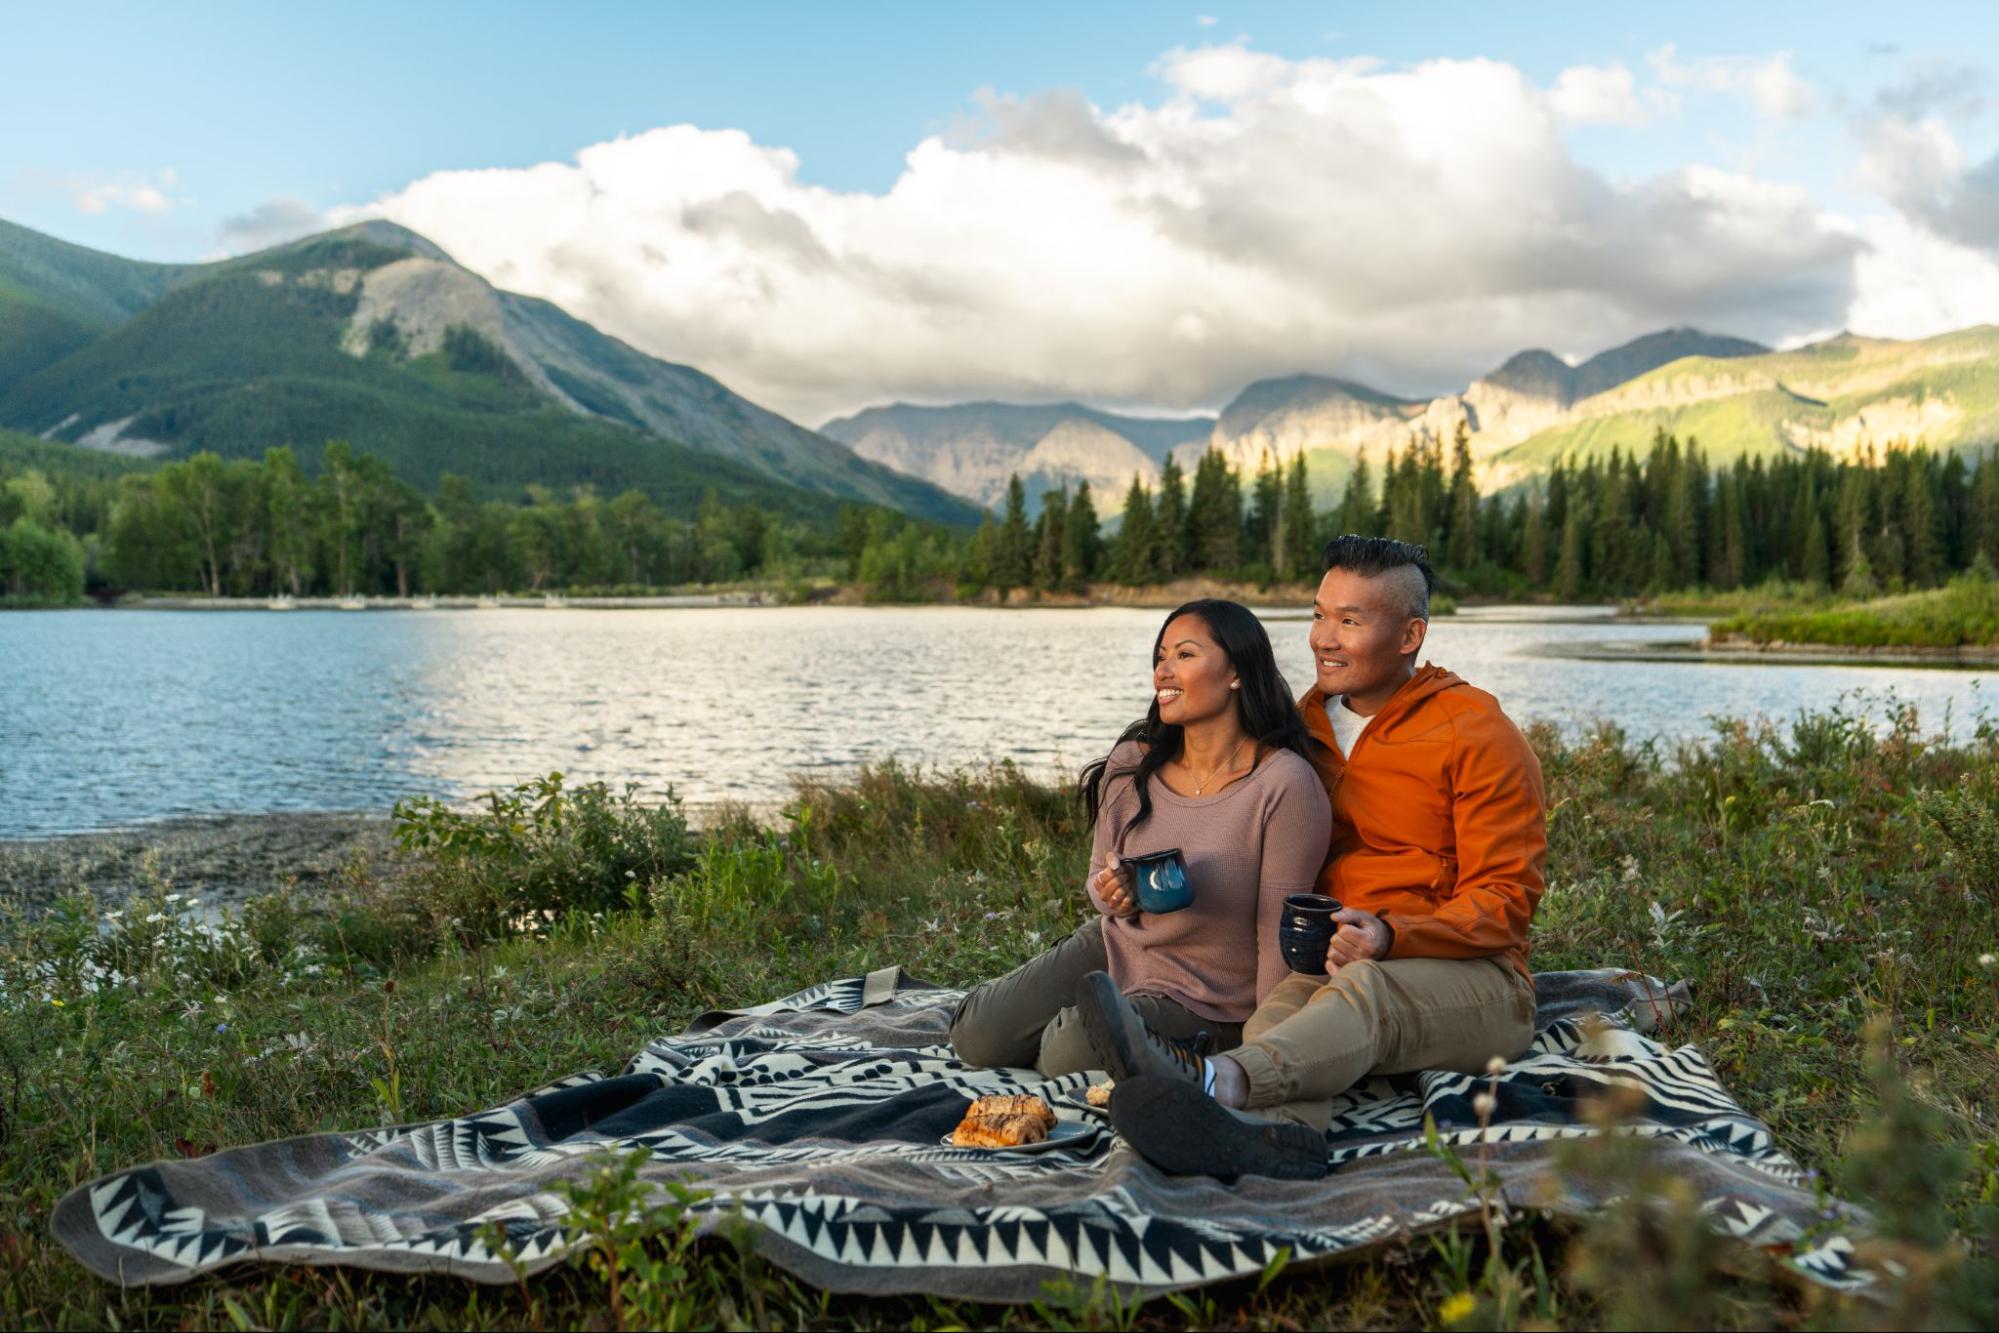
left=1077, top=536, right=1547, bottom=1179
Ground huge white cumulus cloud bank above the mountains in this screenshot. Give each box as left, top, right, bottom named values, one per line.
left=328, top=42, right=1863, bottom=422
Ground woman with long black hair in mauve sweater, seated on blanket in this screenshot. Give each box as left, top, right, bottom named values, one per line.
left=952, top=600, right=1331, bottom=1077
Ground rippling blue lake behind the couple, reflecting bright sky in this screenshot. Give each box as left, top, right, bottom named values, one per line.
left=0, top=608, right=1987, bottom=837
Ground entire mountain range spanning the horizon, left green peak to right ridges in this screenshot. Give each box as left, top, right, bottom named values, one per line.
left=0, top=210, right=1999, bottom=524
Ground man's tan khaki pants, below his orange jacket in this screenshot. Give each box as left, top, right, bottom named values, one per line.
left=1229, top=957, right=1533, bottom=1131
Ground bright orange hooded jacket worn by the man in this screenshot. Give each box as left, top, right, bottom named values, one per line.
left=1297, top=666, right=1547, bottom=975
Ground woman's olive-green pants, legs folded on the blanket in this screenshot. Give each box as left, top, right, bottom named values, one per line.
left=952, top=921, right=1243, bottom=1079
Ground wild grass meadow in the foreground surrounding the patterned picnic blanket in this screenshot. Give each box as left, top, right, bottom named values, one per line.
left=0, top=719, right=1999, bottom=1329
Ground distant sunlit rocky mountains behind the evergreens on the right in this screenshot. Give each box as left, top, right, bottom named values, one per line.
left=822, top=326, right=1999, bottom=508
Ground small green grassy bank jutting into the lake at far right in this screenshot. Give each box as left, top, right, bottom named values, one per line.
left=1711, top=574, right=1999, bottom=648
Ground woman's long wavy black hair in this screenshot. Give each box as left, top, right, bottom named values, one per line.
left=1075, top=598, right=1311, bottom=825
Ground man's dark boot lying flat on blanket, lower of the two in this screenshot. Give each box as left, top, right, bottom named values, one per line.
left=1111, top=1075, right=1331, bottom=1181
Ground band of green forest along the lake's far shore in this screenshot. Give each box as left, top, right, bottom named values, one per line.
left=0, top=432, right=1999, bottom=604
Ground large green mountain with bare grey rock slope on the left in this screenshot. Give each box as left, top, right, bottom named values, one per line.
left=0, top=222, right=978, bottom=524
